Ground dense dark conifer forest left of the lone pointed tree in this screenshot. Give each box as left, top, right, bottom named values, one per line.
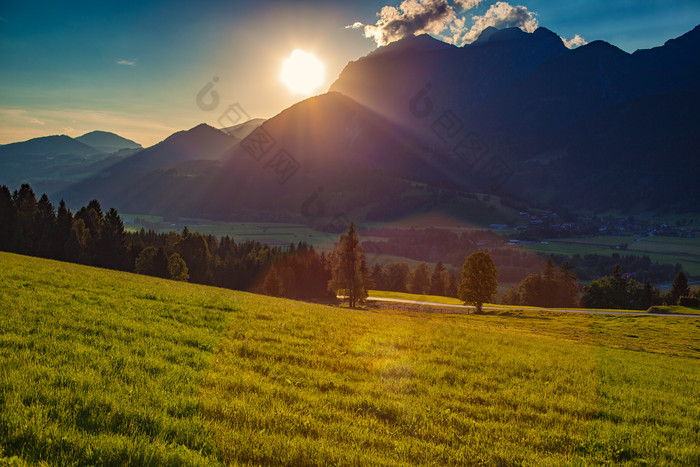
left=0, top=184, right=331, bottom=299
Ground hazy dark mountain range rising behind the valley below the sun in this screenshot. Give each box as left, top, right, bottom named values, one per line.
left=0, top=27, right=700, bottom=223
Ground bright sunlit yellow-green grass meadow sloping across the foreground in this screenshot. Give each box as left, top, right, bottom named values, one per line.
left=0, top=253, right=700, bottom=465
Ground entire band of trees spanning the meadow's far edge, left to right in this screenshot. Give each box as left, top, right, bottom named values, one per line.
left=0, top=184, right=700, bottom=310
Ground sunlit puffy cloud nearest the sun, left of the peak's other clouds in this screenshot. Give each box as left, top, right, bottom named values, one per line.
left=364, top=0, right=457, bottom=46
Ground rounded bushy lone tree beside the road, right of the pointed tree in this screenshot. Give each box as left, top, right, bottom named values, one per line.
left=458, top=251, right=498, bottom=313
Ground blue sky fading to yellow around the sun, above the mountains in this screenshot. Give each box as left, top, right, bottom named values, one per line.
left=0, top=0, right=700, bottom=145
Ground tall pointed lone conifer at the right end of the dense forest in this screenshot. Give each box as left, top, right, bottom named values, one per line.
left=328, top=222, right=369, bottom=307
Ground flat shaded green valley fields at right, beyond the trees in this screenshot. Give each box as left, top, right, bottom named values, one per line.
left=524, top=236, right=700, bottom=276
